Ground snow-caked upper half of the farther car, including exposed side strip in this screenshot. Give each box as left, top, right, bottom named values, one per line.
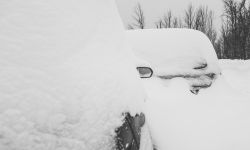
left=127, top=29, right=220, bottom=94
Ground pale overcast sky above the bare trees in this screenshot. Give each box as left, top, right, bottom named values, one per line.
left=116, top=0, right=227, bottom=30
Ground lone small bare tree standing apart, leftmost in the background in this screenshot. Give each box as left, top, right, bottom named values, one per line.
left=128, top=3, right=145, bottom=29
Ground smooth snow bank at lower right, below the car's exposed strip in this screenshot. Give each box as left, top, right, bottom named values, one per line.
left=144, top=76, right=250, bottom=150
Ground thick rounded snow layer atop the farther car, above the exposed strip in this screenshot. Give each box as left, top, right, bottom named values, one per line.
left=127, top=29, right=220, bottom=75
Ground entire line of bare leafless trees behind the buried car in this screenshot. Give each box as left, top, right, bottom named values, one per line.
left=128, top=0, right=250, bottom=59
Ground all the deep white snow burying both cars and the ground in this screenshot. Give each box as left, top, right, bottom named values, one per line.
left=0, top=0, right=250, bottom=150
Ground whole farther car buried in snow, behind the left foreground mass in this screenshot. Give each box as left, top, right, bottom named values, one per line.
left=127, top=29, right=250, bottom=150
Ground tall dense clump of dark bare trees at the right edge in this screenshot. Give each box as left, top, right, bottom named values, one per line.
left=222, top=0, right=250, bottom=59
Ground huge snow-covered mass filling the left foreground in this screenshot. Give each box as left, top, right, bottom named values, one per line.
left=0, top=0, right=144, bottom=150
